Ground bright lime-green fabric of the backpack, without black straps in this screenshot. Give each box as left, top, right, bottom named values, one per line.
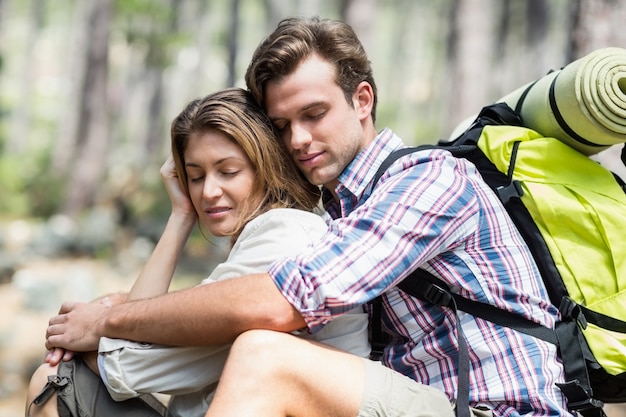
left=478, top=122, right=626, bottom=375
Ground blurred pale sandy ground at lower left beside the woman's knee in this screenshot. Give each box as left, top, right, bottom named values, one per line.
left=0, top=259, right=135, bottom=417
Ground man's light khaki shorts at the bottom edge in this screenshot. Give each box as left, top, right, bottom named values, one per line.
left=357, top=359, right=493, bottom=417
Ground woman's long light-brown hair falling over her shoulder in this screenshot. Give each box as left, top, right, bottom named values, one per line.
left=171, top=88, right=320, bottom=242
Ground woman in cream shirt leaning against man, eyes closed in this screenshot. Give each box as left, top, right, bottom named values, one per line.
left=27, top=89, right=370, bottom=416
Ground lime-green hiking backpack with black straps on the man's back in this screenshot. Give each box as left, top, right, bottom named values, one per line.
left=372, top=103, right=626, bottom=417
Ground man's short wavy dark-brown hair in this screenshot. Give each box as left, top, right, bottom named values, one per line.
left=246, top=17, right=378, bottom=121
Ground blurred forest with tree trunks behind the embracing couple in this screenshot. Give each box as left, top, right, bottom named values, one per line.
left=0, top=0, right=626, bottom=416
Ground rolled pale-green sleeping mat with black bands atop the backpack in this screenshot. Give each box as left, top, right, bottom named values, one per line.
left=499, top=47, right=626, bottom=155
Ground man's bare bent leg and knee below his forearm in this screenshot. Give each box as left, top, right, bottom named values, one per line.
left=206, top=330, right=365, bottom=417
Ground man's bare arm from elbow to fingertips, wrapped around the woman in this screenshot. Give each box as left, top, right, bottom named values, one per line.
left=46, top=273, right=305, bottom=351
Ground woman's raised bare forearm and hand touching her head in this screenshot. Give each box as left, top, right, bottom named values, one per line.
left=128, top=156, right=197, bottom=301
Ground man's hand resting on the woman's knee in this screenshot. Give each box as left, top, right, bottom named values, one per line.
left=46, top=302, right=111, bottom=359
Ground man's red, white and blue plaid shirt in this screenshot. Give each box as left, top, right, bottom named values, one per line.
left=270, top=129, right=569, bottom=416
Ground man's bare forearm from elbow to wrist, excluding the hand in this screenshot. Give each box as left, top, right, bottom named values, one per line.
left=98, top=274, right=304, bottom=346
